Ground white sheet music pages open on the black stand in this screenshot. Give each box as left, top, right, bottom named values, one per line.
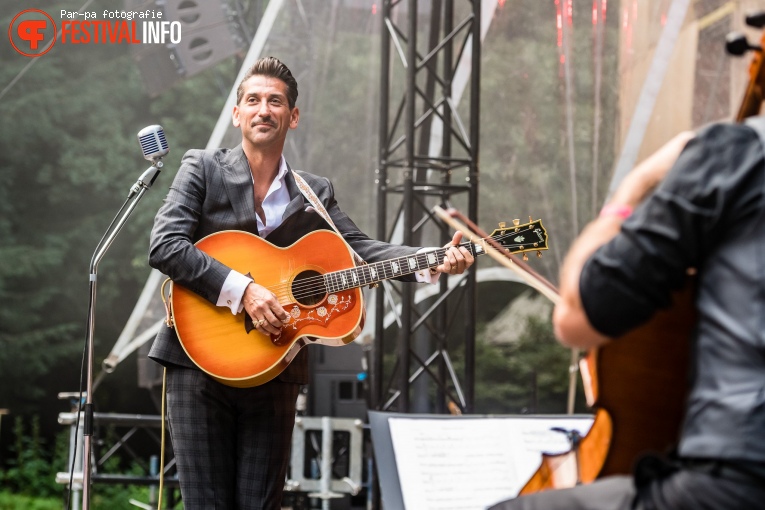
left=389, top=417, right=592, bottom=510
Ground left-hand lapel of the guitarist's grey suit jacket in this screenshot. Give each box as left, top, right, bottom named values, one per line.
left=221, top=145, right=258, bottom=234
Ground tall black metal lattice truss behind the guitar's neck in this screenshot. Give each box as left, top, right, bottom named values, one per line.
left=370, top=0, right=481, bottom=414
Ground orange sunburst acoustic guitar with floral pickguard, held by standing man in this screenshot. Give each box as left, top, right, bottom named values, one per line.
left=170, top=220, right=548, bottom=387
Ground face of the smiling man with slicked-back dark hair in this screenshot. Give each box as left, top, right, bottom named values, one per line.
left=233, top=75, right=300, bottom=150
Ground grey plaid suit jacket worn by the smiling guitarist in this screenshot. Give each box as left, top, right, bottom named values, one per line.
left=149, top=145, right=417, bottom=384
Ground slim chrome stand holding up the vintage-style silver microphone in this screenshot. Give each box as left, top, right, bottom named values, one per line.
left=78, top=158, right=164, bottom=510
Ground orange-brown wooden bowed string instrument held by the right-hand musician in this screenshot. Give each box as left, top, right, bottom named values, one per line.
left=520, top=13, right=765, bottom=495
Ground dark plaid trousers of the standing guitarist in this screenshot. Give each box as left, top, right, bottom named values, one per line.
left=167, top=366, right=300, bottom=510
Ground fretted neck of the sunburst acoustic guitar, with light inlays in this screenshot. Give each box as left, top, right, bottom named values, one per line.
left=324, top=242, right=485, bottom=292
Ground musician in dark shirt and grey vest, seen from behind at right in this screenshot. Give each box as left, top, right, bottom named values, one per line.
left=491, top=118, right=765, bottom=510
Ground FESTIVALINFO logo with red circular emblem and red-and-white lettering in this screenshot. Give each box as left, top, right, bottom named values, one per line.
left=8, top=9, right=181, bottom=58
